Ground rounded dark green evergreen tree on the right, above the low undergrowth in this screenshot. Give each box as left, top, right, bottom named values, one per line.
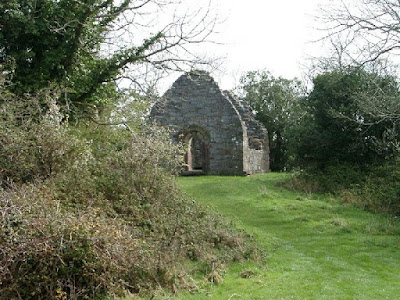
left=294, top=67, right=400, bottom=169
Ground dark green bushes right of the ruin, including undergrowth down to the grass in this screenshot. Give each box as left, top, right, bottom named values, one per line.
left=282, top=67, right=400, bottom=215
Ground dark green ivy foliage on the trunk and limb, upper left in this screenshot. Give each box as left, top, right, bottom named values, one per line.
left=0, top=0, right=168, bottom=113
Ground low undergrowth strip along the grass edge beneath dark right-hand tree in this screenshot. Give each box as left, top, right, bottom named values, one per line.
left=285, top=159, right=400, bottom=216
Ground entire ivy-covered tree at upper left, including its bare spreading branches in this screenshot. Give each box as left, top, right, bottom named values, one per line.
left=0, top=0, right=216, bottom=115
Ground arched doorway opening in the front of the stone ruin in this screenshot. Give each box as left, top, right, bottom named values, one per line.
left=182, top=126, right=210, bottom=175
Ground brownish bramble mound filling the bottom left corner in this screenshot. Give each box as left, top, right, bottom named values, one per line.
left=0, top=185, right=142, bottom=299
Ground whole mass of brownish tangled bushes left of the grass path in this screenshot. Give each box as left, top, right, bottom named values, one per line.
left=0, top=92, right=253, bottom=299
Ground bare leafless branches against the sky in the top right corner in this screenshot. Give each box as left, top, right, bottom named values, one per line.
left=322, top=0, right=400, bottom=64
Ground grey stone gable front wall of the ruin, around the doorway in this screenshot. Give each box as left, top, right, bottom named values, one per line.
left=150, top=71, right=245, bottom=175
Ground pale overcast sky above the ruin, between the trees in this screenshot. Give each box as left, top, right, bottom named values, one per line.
left=170, top=0, right=330, bottom=89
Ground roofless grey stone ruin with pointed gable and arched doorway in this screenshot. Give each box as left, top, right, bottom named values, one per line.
left=150, top=71, right=269, bottom=175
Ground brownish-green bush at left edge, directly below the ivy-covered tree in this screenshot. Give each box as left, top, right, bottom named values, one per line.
left=0, top=89, right=88, bottom=186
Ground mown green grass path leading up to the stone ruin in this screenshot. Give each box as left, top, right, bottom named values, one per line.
left=179, top=173, right=400, bottom=299
